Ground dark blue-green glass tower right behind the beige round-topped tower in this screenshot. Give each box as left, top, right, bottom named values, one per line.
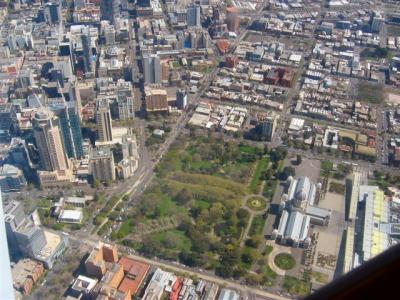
left=51, top=101, right=83, bottom=158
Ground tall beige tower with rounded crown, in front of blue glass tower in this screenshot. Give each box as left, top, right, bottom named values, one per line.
left=32, top=107, right=68, bottom=171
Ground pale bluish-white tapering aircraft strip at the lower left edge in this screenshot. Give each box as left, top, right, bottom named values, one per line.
left=0, top=191, right=15, bottom=299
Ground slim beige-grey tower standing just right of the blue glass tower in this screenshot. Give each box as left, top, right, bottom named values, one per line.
left=96, top=99, right=113, bottom=142
